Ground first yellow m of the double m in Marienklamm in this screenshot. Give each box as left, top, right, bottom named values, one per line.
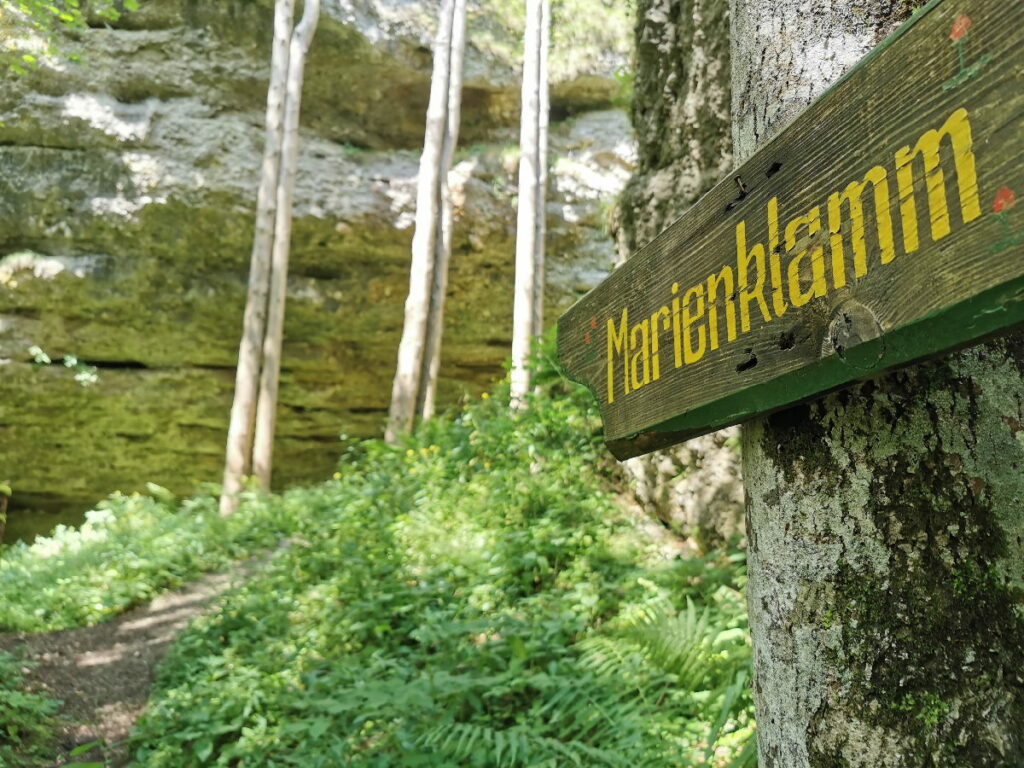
left=828, top=165, right=897, bottom=288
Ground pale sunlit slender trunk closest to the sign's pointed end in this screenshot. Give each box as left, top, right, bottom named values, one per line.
left=511, top=0, right=548, bottom=407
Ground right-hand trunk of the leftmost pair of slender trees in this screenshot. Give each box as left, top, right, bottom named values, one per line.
left=253, top=0, right=321, bottom=490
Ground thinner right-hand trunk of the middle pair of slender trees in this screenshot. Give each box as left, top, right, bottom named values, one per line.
left=416, top=0, right=466, bottom=421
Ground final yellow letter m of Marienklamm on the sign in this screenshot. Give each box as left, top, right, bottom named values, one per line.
left=896, top=108, right=981, bottom=253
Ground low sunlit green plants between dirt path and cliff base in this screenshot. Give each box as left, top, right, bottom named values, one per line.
left=0, top=486, right=289, bottom=632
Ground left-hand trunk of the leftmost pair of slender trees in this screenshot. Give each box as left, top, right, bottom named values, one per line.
left=220, top=0, right=295, bottom=515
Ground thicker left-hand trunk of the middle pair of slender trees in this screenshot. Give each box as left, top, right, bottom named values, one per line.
left=384, top=0, right=455, bottom=443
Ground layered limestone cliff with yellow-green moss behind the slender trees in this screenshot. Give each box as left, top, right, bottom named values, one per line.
left=0, top=0, right=635, bottom=520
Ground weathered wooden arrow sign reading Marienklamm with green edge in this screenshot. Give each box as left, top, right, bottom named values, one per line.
left=558, top=0, right=1024, bottom=459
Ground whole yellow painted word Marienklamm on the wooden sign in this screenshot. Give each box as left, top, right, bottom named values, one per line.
left=607, top=109, right=981, bottom=376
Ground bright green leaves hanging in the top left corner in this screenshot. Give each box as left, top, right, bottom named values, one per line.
left=0, top=0, right=138, bottom=75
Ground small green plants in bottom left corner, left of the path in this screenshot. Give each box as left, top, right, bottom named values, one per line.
left=0, top=651, right=60, bottom=766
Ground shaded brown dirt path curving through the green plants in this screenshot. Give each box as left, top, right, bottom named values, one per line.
left=0, top=558, right=253, bottom=766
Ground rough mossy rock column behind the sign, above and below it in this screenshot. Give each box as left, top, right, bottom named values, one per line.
left=612, top=0, right=743, bottom=546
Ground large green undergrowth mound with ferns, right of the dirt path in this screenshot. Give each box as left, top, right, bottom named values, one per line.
left=125, top=360, right=754, bottom=768
